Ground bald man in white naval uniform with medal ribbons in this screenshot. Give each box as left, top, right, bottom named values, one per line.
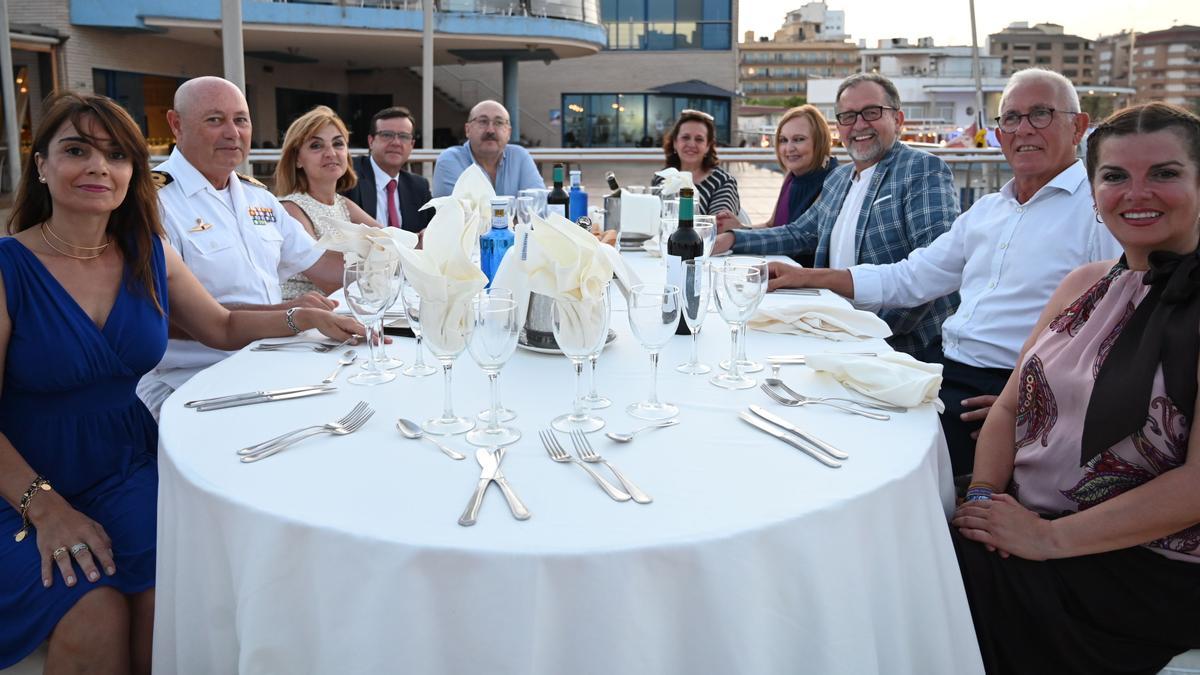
left=138, top=77, right=342, bottom=418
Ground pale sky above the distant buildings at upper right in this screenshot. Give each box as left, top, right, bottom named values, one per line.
left=738, top=0, right=1200, bottom=47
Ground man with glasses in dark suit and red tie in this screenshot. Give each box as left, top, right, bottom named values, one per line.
left=344, top=106, right=433, bottom=232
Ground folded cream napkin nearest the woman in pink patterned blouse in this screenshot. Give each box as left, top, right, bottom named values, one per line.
left=804, top=352, right=946, bottom=412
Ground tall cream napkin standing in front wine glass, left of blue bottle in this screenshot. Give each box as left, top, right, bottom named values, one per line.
left=401, top=196, right=487, bottom=351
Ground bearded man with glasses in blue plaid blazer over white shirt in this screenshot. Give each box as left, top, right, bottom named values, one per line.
left=713, top=73, right=959, bottom=362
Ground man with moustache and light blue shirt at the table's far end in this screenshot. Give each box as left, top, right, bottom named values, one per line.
left=433, top=101, right=546, bottom=197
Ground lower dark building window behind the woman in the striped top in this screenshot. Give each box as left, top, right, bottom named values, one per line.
left=563, top=94, right=730, bottom=148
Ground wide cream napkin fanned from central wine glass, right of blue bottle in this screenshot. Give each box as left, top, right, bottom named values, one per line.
left=492, top=214, right=631, bottom=346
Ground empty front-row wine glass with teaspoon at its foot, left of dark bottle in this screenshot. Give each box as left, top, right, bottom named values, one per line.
left=625, top=283, right=679, bottom=419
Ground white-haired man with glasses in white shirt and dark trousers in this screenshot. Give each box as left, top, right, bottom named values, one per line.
left=770, top=68, right=1121, bottom=476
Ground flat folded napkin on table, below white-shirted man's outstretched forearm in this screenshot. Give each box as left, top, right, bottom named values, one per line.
left=746, top=295, right=892, bottom=342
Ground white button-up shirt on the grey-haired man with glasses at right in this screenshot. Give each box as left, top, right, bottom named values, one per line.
left=850, top=160, right=1121, bottom=369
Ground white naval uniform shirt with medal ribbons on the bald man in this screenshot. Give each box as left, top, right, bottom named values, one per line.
left=143, top=148, right=324, bottom=389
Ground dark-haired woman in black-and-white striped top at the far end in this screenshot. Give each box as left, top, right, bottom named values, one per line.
left=650, top=110, right=742, bottom=216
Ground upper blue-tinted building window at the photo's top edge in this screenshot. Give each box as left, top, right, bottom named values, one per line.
left=600, top=0, right=733, bottom=50
